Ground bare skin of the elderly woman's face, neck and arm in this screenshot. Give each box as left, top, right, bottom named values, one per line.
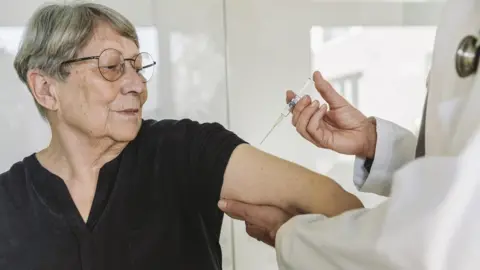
left=28, top=21, right=363, bottom=224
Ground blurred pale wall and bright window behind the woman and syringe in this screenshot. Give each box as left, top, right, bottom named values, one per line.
left=0, top=0, right=443, bottom=270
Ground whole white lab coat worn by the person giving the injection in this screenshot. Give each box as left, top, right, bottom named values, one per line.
left=276, top=0, right=480, bottom=270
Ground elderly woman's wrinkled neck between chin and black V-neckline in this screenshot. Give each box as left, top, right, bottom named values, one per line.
left=37, top=123, right=127, bottom=181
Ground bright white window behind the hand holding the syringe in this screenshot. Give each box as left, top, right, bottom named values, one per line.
left=311, top=26, right=435, bottom=132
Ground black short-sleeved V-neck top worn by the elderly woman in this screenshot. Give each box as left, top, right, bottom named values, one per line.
left=0, top=119, right=245, bottom=270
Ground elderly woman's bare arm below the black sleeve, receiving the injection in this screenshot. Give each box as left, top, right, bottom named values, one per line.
left=221, top=144, right=361, bottom=215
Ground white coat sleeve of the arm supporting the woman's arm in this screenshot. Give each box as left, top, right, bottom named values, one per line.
left=276, top=128, right=480, bottom=270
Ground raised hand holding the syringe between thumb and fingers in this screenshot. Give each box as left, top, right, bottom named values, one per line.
left=287, top=71, right=377, bottom=158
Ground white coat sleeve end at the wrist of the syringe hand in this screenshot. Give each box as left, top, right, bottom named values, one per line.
left=353, top=118, right=417, bottom=196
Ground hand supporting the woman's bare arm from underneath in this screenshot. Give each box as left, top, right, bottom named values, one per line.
left=218, top=200, right=293, bottom=247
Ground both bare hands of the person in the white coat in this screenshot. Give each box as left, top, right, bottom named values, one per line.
left=218, top=72, right=377, bottom=246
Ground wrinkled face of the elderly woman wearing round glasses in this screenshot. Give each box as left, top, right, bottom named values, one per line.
left=56, top=24, right=147, bottom=142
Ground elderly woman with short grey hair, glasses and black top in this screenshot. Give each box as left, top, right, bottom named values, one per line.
left=0, top=3, right=361, bottom=270
